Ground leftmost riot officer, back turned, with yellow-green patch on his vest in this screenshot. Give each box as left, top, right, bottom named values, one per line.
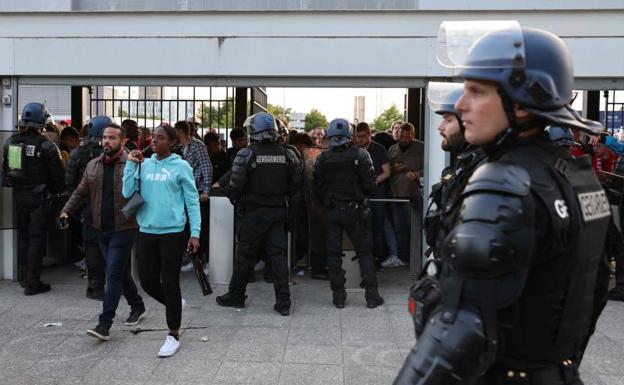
left=2, top=103, right=65, bottom=295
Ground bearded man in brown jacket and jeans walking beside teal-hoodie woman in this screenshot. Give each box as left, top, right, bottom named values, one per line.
left=60, top=123, right=145, bottom=341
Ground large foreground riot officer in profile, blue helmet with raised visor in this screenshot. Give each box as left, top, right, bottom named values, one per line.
left=395, top=22, right=610, bottom=384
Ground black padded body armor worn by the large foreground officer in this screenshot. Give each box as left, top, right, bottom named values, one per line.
left=395, top=135, right=610, bottom=384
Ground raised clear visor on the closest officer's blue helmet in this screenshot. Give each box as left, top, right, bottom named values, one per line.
left=437, top=20, right=526, bottom=69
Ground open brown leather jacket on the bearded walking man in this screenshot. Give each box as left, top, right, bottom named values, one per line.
left=61, top=151, right=139, bottom=231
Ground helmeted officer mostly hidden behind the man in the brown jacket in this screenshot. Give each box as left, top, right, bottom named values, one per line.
left=65, top=115, right=114, bottom=300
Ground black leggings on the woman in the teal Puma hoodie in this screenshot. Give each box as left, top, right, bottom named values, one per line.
left=137, top=232, right=186, bottom=330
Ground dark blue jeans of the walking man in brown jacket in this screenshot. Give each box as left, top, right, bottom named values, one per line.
left=99, top=230, right=145, bottom=328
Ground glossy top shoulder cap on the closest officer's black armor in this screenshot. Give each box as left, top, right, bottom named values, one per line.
left=463, top=162, right=531, bottom=196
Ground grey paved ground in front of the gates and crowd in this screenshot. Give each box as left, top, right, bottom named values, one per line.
left=0, top=267, right=624, bottom=385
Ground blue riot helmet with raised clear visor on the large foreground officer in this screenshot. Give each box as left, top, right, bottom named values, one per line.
left=438, top=21, right=601, bottom=135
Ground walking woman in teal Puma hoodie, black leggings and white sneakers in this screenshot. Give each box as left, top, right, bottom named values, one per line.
left=122, top=126, right=201, bottom=357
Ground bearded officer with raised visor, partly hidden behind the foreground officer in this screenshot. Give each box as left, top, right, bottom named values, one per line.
left=425, top=82, right=486, bottom=257
